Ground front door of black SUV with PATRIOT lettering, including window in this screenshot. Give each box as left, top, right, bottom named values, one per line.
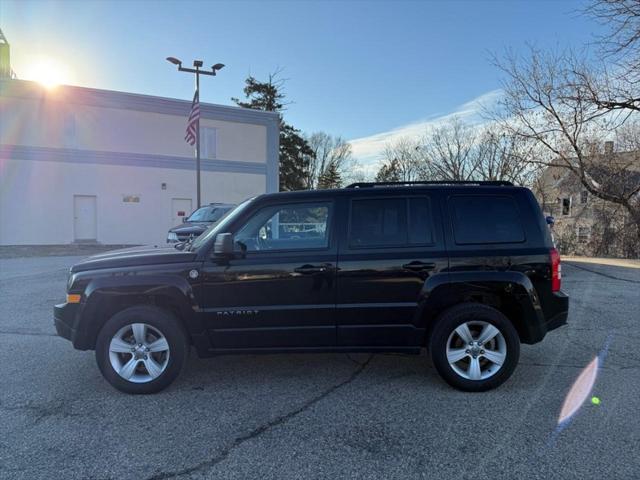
left=201, top=201, right=337, bottom=349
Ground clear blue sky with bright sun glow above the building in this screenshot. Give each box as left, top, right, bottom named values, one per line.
left=0, top=0, right=601, bottom=169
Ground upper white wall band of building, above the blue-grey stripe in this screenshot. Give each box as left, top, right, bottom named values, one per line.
left=0, top=95, right=267, bottom=163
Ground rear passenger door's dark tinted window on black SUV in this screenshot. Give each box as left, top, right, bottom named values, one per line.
left=349, top=197, right=433, bottom=248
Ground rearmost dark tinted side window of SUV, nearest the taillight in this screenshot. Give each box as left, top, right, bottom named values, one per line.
left=449, top=195, right=525, bottom=245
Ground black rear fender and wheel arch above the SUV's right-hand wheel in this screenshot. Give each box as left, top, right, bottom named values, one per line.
left=416, top=270, right=547, bottom=343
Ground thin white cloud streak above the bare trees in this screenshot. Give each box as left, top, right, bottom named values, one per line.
left=349, top=90, right=502, bottom=175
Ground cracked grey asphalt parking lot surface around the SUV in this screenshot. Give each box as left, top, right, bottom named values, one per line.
left=0, top=253, right=640, bottom=480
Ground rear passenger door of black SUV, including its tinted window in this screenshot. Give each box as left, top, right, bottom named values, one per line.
left=336, top=192, right=448, bottom=347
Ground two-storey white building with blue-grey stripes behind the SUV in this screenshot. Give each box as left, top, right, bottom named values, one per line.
left=0, top=80, right=278, bottom=245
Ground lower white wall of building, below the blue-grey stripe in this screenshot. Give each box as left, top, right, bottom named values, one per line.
left=0, top=159, right=265, bottom=245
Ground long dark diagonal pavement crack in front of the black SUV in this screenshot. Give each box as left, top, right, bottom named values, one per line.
left=147, top=354, right=374, bottom=480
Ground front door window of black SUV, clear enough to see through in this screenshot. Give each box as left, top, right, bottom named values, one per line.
left=235, top=202, right=331, bottom=252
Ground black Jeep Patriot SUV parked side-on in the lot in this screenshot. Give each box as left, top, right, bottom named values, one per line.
left=54, top=182, right=569, bottom=393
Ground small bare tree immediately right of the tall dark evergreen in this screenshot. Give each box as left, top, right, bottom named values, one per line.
left=305, top=132, right=355, bottom=189
